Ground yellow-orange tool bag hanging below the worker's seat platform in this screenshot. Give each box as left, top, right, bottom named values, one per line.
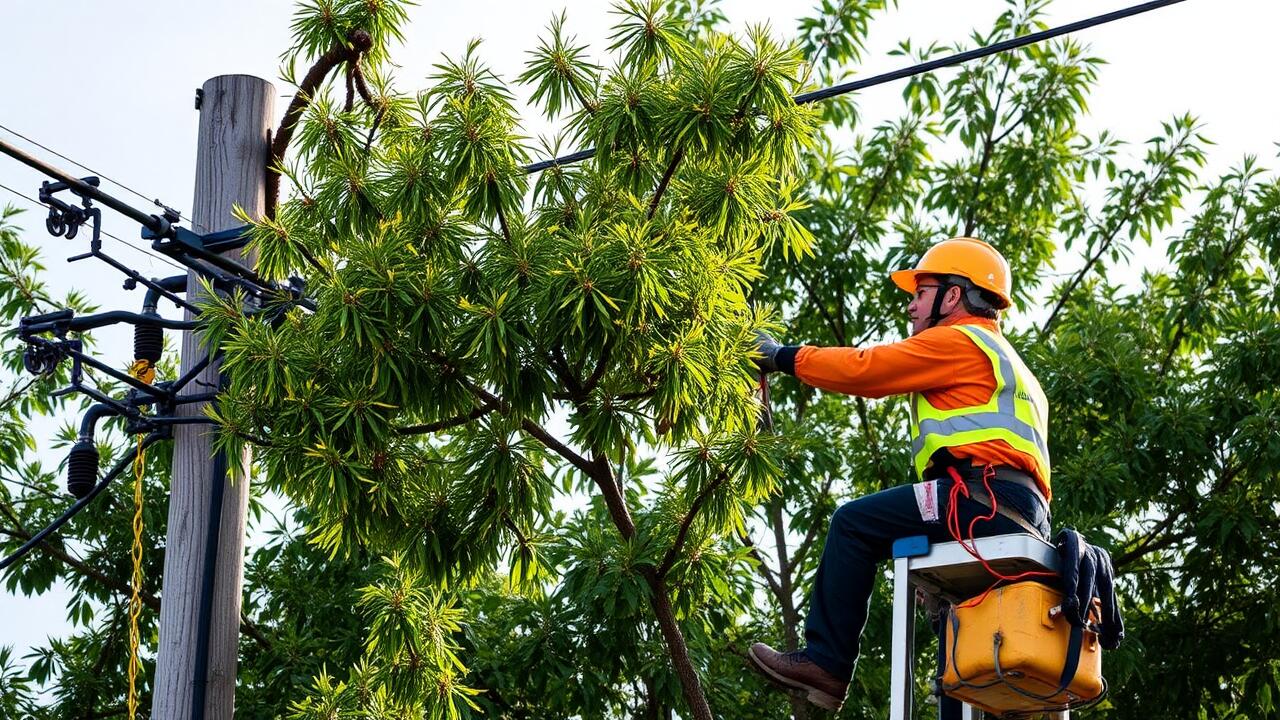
left=941, top=580, right=1106, bottom=715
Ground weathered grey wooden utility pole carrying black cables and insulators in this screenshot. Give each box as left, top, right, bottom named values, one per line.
left=151, top=76, right=275, bottom=720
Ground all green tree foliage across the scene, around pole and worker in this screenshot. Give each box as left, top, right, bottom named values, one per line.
left=0, top=0, right=1280, bottom=719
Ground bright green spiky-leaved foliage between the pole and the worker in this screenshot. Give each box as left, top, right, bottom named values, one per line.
left=206, top=0, right=815, bottom=717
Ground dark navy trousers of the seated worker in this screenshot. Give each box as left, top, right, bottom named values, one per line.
left=804, top=478, right=1050, bottom=680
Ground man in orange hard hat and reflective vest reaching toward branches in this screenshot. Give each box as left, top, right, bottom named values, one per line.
left=749, top=237, right=1052, bottom=717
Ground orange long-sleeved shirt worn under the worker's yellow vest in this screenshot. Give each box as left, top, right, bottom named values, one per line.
left=795, top=316, right=1052, bottom=498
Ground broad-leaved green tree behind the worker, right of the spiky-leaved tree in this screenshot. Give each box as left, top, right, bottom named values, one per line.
left=756, top=3, right=1280, bottom=717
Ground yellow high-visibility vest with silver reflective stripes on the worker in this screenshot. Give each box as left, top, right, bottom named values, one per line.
left=911, top=325, right=1050, bottom=486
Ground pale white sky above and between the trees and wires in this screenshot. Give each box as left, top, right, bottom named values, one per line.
left=0, top=0, right=1280, bottom=671
